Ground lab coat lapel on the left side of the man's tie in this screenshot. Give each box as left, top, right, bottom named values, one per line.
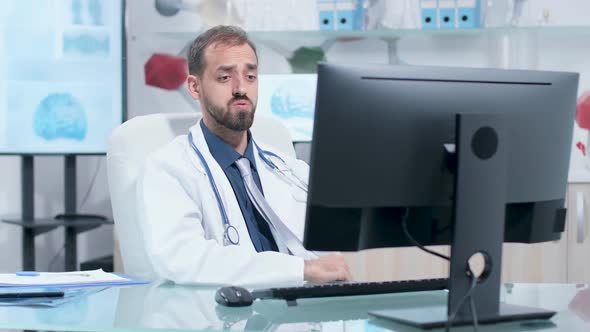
left=190, top=123, right=256, bottom=251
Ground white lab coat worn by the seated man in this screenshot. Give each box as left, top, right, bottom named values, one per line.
left=137, top=124, right=309, bottom=286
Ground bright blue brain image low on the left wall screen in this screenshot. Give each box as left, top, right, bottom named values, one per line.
left=33, top=93, right=87, bottom=141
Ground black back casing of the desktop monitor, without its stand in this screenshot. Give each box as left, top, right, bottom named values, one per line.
left=304, top=64, right=578, bottom=251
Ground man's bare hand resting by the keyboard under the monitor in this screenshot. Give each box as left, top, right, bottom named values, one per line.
left=303, top=255, right=352, bottom=283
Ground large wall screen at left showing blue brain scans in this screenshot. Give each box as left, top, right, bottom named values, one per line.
left=0, top=0, right=123, bottom=154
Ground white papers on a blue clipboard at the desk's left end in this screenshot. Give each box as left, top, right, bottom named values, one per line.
left=0, top=269, right=148, bottom=288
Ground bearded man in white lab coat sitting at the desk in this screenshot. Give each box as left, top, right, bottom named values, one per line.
left=137, top=26, right=351, bottom=285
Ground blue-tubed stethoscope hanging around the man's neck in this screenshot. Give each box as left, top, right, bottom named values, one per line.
left=188, top=132, right=307, bottom=246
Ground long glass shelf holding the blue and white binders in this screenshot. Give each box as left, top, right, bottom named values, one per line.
left=159, top=25, right=590, bottom=41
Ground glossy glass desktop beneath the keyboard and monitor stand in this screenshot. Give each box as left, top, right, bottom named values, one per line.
left=0, top=284, right=590, bottom=332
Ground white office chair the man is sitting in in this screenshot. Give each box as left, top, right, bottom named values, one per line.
left=107, top=113, right=295, bottom=278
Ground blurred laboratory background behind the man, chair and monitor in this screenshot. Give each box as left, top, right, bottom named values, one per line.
left=0, top=0, right=590, bottom=283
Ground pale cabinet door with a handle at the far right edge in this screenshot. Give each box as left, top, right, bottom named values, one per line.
left=567, top=183, right=590, bottom=283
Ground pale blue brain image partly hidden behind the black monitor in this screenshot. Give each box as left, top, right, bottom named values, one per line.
left=270, top=80, right=315, bottom=119
